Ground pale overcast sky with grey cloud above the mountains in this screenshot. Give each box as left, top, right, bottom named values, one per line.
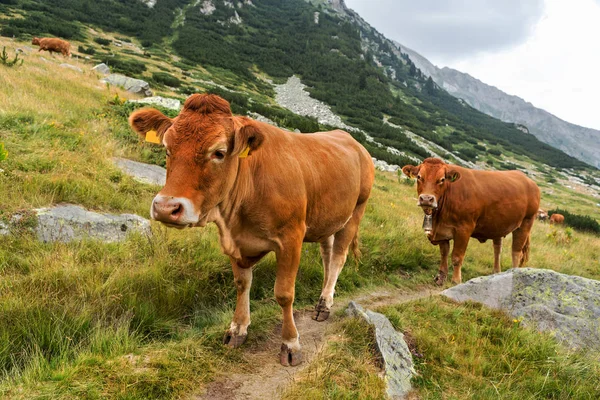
left=345, top=0, right=600, bottom=129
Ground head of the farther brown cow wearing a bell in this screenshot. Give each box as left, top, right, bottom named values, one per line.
left=402, top=158, right=460, bottom=214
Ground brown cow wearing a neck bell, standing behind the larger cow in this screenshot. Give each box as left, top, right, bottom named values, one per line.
left=402, top=158, right=540, bottom=285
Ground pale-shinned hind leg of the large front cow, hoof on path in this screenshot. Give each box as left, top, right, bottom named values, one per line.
left=313, top=202, right=367, bottom=321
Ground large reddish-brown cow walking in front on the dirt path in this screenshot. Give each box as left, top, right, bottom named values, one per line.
left=129, top=94, right=375, bottom=365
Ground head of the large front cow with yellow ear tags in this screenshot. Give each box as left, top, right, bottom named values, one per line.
left=129, top=94, right=263, bottom=227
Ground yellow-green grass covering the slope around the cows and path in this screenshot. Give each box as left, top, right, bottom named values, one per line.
left=0, top=39, right=600, bottom=399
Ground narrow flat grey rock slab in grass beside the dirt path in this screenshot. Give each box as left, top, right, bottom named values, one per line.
left=346, top=301, right=416, bottom=399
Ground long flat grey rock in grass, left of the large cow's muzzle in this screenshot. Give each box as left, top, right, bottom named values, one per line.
left=10, top=204, right=152, bottom=242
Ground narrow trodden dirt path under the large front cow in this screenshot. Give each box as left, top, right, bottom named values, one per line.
left=195, top=286, right=440, bottom=400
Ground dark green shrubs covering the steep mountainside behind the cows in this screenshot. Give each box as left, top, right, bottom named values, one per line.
left=0, top=0, right=588, bottom=168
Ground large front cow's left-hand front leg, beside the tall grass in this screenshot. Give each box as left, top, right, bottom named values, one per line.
left=223, top=259, right=252, bottom=347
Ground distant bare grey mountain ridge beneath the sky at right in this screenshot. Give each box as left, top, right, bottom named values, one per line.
left=396, top=43, right=600, bottom=167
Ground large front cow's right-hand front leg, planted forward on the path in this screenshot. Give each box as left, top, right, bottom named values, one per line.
left=275, top=239, right=302, bottom=367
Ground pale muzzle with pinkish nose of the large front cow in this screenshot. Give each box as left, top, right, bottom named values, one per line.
left=150, top=194, right=199, bottom=228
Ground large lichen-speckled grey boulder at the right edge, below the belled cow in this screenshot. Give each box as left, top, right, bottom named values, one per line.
left=442, top=268, right=600, bottom=349
